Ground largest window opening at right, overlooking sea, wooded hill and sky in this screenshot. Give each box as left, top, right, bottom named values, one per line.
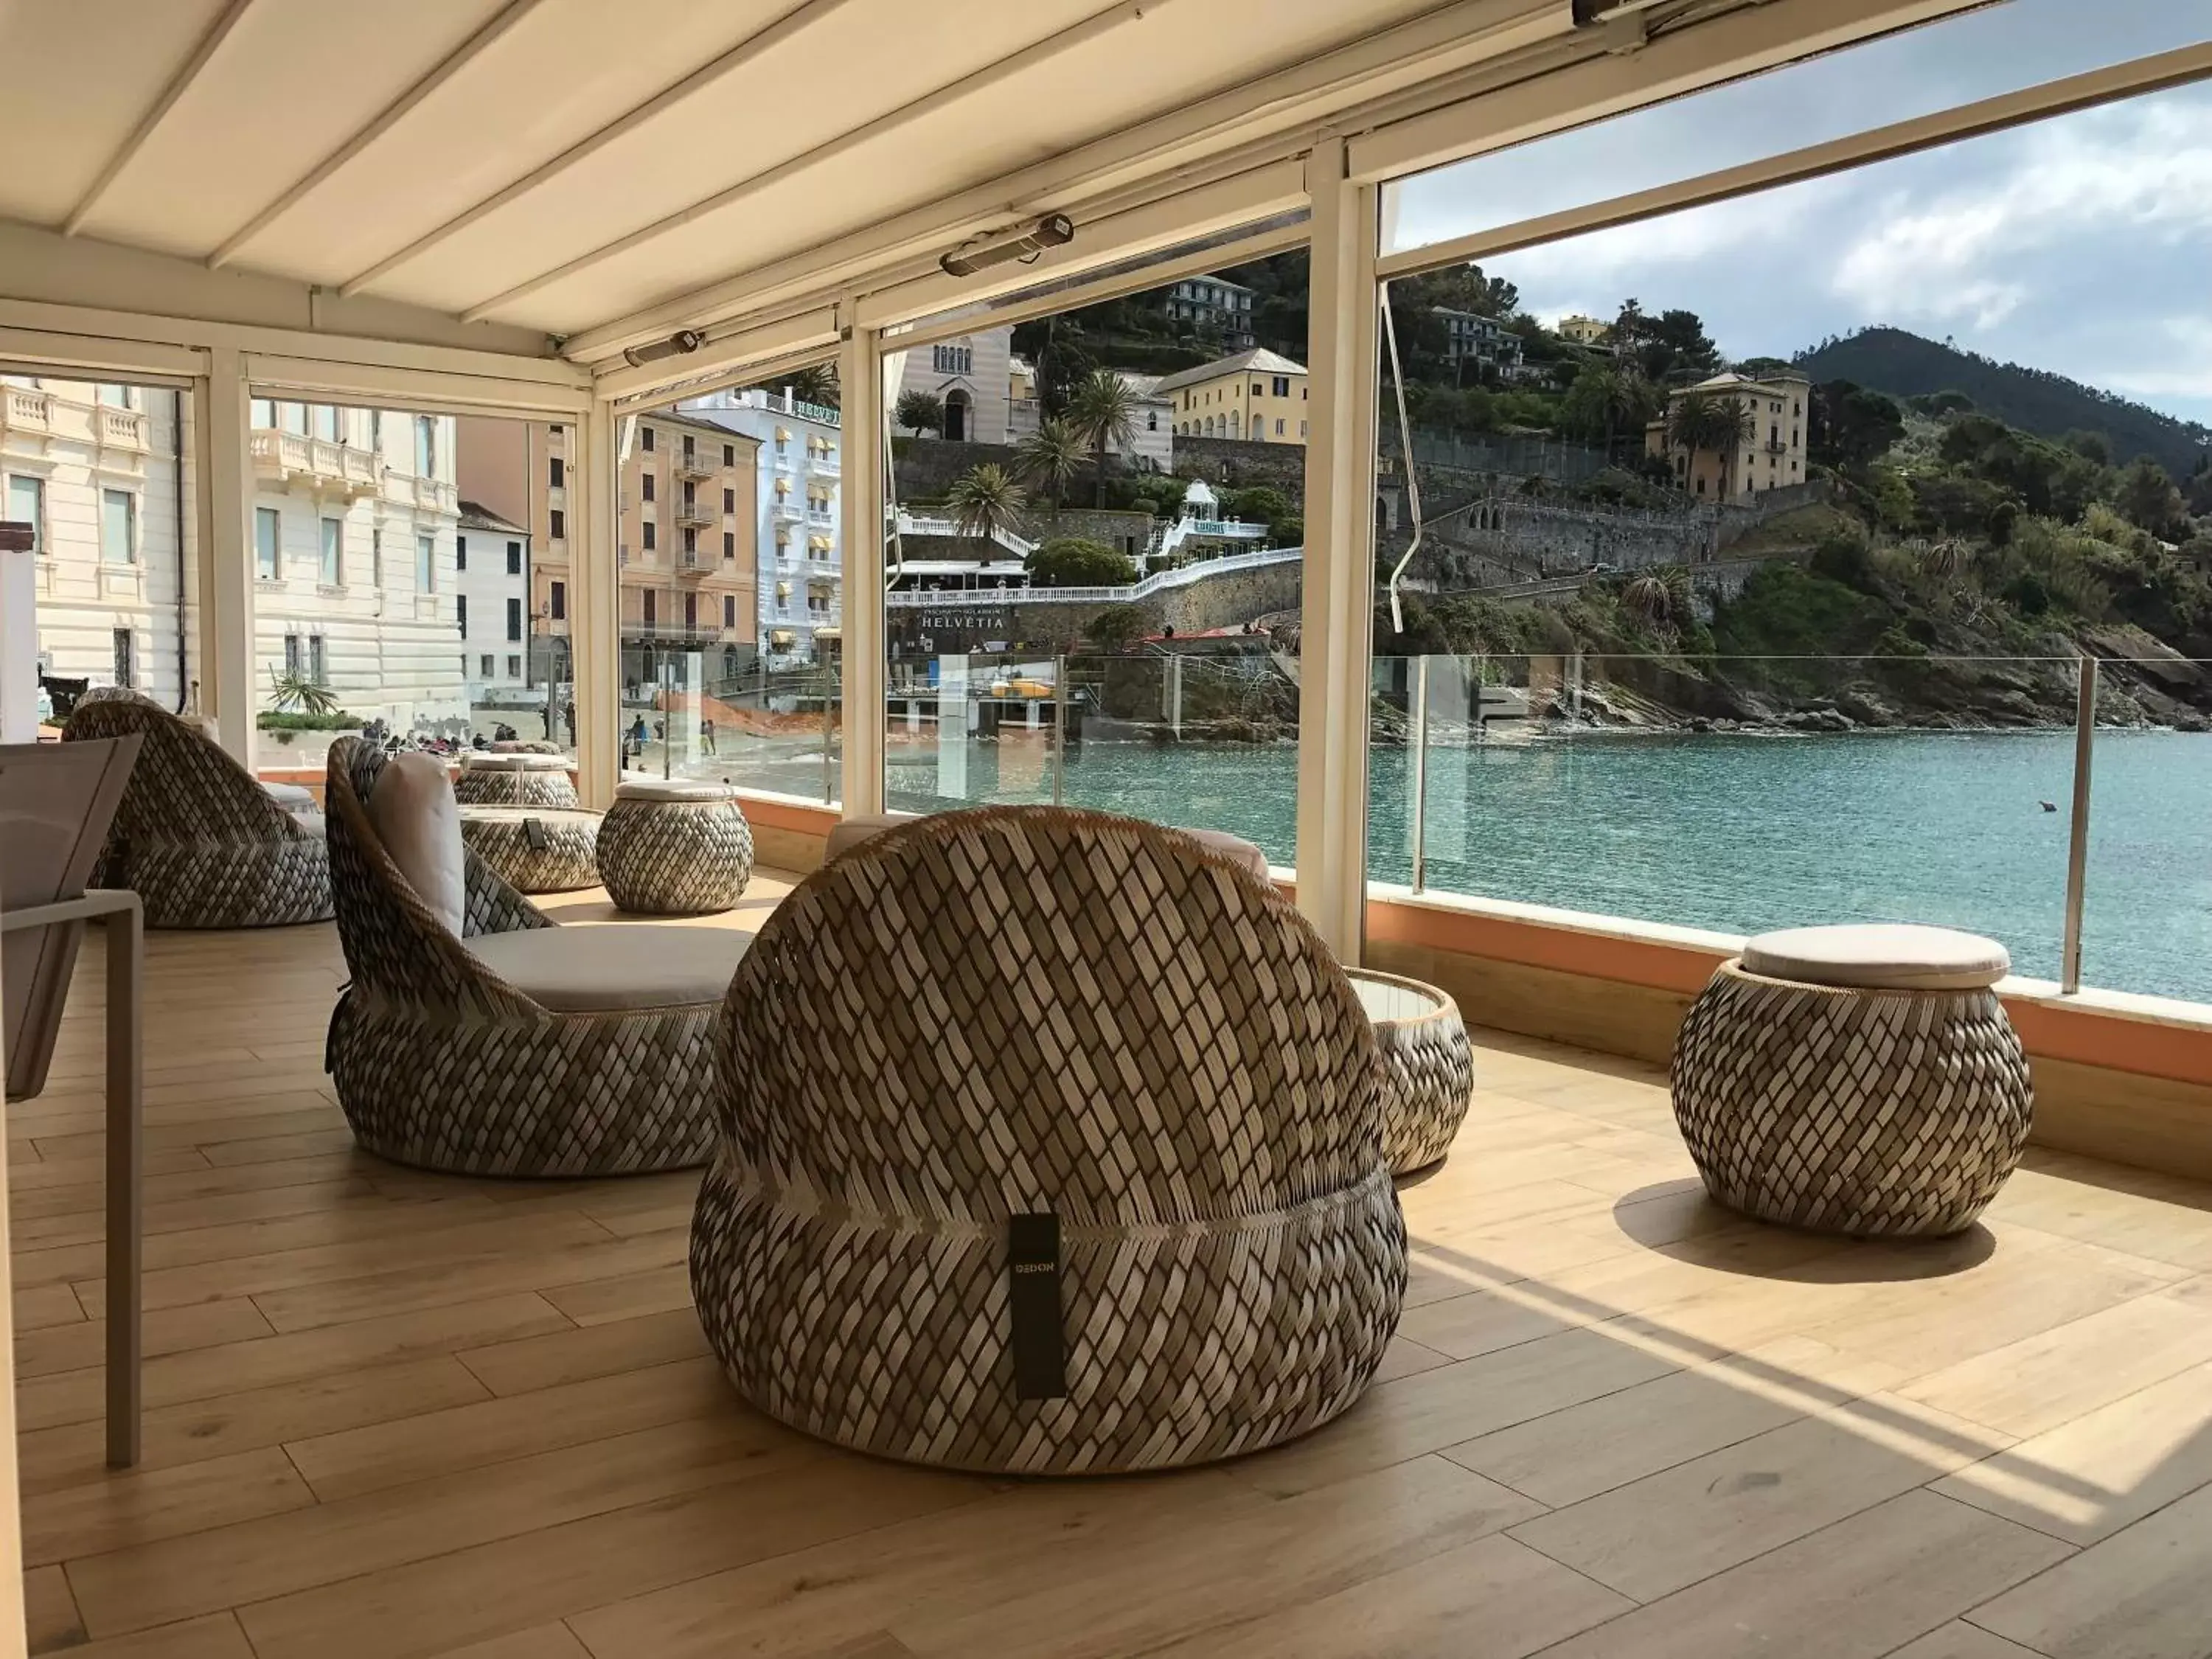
left=1369, top=16, right=2212, bottom=1000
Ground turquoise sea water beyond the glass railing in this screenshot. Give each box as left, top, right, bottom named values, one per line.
left=872, top=732, right=2212, bottom=1002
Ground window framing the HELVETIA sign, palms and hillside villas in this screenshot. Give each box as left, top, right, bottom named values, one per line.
left=883, top=250, right=1312, bottom=865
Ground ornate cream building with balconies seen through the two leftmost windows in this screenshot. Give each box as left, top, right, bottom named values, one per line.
left=0, top=376, right=469, bottom=730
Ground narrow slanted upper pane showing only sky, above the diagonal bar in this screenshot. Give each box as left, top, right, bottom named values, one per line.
left=1382, top=0, right=2205, bottom=254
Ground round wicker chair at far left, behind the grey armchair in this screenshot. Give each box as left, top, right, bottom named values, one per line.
left=62, top=690, right=330, bottom=927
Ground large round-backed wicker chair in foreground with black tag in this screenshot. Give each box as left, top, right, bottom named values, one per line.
left=690, top=807, right=1407, bottom=1473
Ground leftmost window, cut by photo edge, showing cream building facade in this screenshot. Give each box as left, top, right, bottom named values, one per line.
left=0, top=374, right=199, bottom=728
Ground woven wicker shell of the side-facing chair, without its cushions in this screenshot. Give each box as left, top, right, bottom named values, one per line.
left=325, top=739, right=741, bottom=1177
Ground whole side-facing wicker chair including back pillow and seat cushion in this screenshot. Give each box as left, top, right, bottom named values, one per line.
left=325, top=739, right=748, bottom=1177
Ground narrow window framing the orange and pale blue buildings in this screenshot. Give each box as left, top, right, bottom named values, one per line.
left=617, top=363, right=845, bottom=801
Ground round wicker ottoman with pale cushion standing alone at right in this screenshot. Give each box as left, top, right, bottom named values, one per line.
left=1672, top=927, right=2033, bottom=1237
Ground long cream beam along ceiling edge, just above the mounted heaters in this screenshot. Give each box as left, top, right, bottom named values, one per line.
left=566, top=0, right=1573, bottom=361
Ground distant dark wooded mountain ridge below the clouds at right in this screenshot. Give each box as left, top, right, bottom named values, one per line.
left=1796, top=327, right=2212, bottom=478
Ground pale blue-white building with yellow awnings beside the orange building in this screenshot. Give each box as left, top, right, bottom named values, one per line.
left=679, top=389, right=845, bottom=668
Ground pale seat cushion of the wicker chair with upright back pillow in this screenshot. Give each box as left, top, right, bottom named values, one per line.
left=462, top=922, right=752, bottom=1013
